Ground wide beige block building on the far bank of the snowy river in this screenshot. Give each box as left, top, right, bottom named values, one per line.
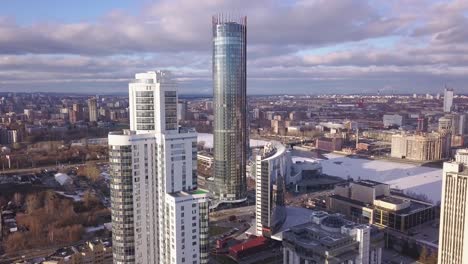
left=391, top=131, right=451, bottom=161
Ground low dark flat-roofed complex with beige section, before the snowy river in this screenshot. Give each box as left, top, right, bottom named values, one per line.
left=327, top=180, right=436, bottom=232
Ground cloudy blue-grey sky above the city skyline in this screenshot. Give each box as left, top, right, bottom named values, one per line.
left=0, top=0, right=468, bottom=94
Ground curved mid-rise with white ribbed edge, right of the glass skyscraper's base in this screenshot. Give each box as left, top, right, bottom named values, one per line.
left=254, top=142, right=291, bottom=237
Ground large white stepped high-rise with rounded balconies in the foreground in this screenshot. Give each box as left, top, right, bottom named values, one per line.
left=109, top=71, right=208, bottom=264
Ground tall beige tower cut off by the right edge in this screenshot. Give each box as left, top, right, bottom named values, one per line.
left=438, top=149, right=468, bottom=264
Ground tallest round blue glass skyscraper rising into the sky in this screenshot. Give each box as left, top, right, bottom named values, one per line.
left=212, top=16, right=247, bottom=201
